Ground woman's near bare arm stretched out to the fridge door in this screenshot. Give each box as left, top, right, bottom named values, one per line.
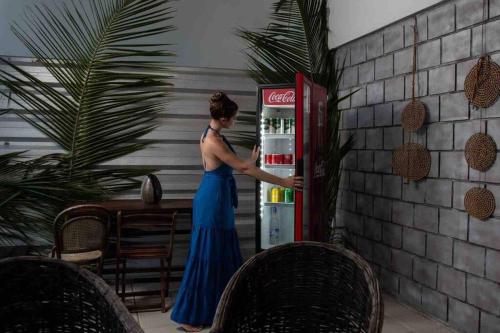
left=205, top=137, right=303, bottom=190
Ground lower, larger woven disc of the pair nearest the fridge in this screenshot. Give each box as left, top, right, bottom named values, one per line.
left=392, top=143, right=431, bottom=181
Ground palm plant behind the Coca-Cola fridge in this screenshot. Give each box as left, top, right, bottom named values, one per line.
left=237, top=0, right=353, bottom=239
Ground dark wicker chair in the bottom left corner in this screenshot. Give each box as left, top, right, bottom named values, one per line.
left=0, top=257, right=144, bottom=333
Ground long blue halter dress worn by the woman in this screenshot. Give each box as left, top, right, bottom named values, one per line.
left=171, top=126, right=243, bottom=326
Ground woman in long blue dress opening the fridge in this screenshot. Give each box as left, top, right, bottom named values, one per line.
left=171, top=92, right=303, bottom=332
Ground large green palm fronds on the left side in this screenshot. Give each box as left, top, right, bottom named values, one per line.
left=0, top=0, right=174, bottom=244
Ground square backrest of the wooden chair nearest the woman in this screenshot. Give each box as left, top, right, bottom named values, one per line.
left=116, top=209, right=177, bottom=255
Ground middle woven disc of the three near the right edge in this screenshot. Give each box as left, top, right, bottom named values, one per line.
left=465, top=133, right=497, bottom=172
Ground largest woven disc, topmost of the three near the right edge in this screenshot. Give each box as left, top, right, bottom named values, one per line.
left=464, top=56, right=500, bottom=108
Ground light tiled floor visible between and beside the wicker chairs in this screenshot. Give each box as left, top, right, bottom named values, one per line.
left=134, top=295, right=456, bottom=333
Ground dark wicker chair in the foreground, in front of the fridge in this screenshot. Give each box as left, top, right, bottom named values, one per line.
left=211, top=242, right=383, bottom=333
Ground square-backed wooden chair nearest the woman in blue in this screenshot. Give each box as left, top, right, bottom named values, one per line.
left=115, top=210, right=177, bottom=312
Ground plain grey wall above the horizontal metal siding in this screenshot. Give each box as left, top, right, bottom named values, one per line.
left=0, top=0, right=274, bottom=69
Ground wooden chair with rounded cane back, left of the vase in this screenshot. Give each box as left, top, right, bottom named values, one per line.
left=52, top=205, right=110, bottom=275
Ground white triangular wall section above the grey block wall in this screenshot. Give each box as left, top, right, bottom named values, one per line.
left=329, top=0, right=443, bottom=47
